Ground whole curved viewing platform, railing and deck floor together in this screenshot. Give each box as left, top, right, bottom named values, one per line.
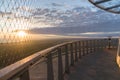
left=0, top=39, right=120, bottom=80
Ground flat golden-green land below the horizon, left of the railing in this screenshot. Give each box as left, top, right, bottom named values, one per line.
left=0, top=39, right=75, bottom=68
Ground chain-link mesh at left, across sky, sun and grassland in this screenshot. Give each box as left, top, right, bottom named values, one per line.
left=0, top=0, right=66, bottom=68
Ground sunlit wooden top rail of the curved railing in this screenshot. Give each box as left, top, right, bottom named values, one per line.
left=0, top=41, right=75, bottom=80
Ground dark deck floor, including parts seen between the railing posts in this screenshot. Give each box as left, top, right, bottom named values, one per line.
left=30, top=49, right=120, bottom=80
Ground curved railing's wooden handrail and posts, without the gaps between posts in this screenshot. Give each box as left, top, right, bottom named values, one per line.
left=0, top=39, right=118, bottom=80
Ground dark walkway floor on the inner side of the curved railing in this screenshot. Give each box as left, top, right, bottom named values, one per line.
left=65, top=49, right=120, bottom=80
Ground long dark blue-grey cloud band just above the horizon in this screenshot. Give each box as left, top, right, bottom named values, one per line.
left=30, top=20, right=120, bottom=37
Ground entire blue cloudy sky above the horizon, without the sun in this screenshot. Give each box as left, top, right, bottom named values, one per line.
left=0, top=0, right=120, bottom=41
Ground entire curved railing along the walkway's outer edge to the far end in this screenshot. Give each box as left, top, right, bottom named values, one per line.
left=0, top=39, right=118, bottom=80
